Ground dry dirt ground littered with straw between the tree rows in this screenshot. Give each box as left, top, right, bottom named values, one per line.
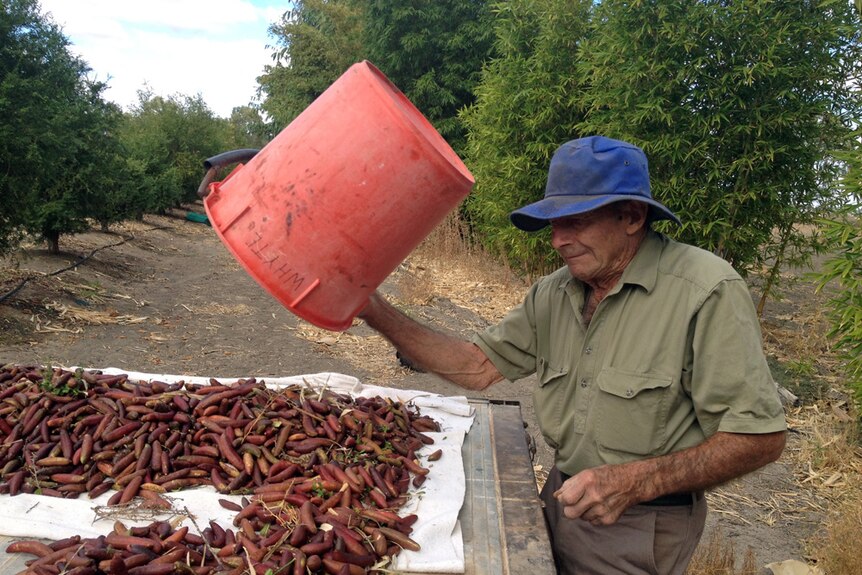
left=0, top=212, right=852, bottom=566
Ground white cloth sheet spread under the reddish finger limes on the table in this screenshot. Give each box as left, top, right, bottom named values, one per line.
left=0, top=368, right=473, bottom=573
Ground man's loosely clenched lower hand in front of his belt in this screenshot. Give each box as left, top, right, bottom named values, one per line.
left=554, top=465, right=638, bottom=525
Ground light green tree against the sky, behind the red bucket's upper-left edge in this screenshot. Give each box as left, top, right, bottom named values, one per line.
left=258, top=0, right=364, bottom=127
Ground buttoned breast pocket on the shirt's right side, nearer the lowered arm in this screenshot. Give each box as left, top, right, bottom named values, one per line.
left=594, top=368, right=673, bottom=463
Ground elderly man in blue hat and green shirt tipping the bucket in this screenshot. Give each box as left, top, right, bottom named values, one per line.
left=360, top=136, right=785, bottom=575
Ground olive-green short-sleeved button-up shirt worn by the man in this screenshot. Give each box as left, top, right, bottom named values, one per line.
left=474, top=232, right=785, bottom=475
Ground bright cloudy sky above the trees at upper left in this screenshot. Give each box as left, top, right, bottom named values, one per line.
left=39, top=0, right=290, bottom=118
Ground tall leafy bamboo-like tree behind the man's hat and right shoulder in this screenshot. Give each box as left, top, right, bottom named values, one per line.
left=578, top=0, right=862, bottom=296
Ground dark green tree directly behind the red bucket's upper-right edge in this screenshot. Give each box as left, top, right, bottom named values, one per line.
left=365, top=0, right=494, bottom=152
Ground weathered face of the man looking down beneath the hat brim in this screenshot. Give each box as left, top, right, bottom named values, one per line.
left=551, top=203, right=633, bottom=287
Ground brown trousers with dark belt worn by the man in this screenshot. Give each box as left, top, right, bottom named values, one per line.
left=542, top=467, right=707, bottom=575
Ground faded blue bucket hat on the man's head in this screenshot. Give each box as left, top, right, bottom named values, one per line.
left=509, top=136, right=680, bottom=232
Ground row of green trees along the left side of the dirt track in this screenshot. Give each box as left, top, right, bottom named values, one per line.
left=0, top=0, right=328, bottom=253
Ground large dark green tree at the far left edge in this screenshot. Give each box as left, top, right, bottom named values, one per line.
left=0, top=0, right=137, bottom=252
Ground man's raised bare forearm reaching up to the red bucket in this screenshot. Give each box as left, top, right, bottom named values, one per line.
left=359, top=294, right=503, bottom=390
